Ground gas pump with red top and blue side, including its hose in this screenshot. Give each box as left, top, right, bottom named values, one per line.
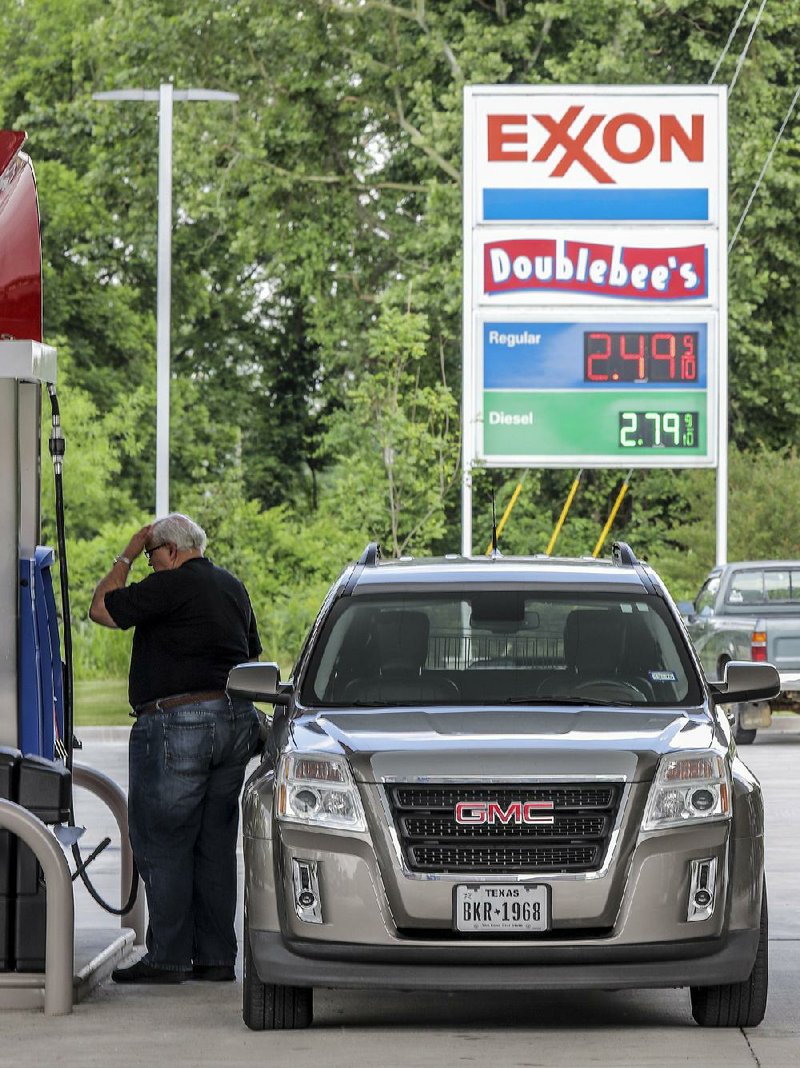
left=0, top=130, right=138, bottom=1004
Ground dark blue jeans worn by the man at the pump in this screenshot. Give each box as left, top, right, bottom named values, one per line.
left=128, top=697, right=258, bottom=971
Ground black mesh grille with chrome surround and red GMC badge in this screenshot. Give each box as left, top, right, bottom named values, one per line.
left=387, top=783, right=622, bottom=875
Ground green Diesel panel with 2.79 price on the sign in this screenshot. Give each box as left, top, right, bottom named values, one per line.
left=483, top=389, right=708, bottom=467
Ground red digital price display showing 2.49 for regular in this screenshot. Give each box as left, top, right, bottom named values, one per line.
left=583, top=330, right=697, bottom=382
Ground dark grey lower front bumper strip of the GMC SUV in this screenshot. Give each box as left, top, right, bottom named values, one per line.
left=249, top=930, right=758, bottom=990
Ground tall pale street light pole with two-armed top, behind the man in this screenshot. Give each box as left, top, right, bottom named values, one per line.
left=92, top=81, right=239, bottom=516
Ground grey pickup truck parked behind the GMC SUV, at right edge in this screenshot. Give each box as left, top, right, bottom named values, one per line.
left=679, top=560, right=800, bottom=745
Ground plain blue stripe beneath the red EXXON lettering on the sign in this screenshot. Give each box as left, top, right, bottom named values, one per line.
left=484, top=189, right=708, bottom=222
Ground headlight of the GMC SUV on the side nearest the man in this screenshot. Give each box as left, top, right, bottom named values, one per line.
left=277, top=753, right=366, bottom=831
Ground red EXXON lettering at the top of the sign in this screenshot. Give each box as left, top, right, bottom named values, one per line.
left=486, top=104, right=704, bottom=185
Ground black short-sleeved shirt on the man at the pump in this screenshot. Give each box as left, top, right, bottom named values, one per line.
left=105, top=556, right=261, bottom=708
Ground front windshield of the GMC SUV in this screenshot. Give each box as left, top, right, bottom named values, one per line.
left=300, top=588, right=702, bottom=707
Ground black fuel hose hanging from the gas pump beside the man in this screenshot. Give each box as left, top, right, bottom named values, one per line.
left=47, top=382, right=139, bottom=916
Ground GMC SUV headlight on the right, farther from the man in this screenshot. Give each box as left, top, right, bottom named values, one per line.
left=642, top=753, right=731, bottom=831
